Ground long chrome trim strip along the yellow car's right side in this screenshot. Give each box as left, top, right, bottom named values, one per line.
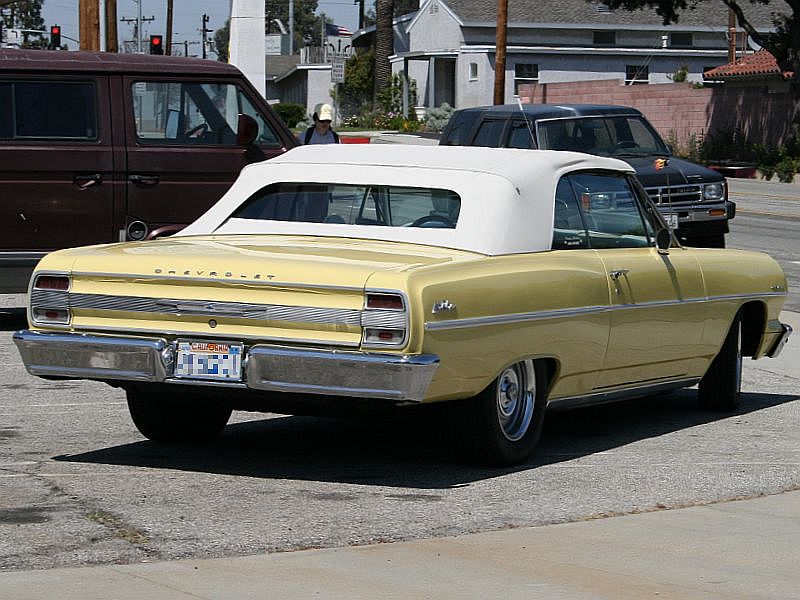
left=425, top=292, right=787, bottom=331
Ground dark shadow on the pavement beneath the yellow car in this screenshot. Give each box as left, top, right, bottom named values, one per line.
left=54, top=390, right=800, bottom=489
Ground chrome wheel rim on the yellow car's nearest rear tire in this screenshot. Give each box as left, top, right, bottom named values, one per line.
left=497, top=360, right=536, bottom=442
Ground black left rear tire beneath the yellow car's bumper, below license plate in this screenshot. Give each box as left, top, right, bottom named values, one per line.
left=126, top=387, right=232, bottom=443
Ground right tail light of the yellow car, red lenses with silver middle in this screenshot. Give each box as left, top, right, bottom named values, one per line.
left=361, top=292, right=408, bottom=348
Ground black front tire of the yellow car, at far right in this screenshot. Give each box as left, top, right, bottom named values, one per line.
left=698, top=313, right=742, bottom=411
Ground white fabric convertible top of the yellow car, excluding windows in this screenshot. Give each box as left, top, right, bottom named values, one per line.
left=177, top=144, right=634, bottom=255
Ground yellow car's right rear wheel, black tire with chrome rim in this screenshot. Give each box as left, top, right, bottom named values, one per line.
left=452, top=360, right=547, bottom=467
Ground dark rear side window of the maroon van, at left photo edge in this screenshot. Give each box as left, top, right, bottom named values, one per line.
left=0, top=81, right=98, bottom=141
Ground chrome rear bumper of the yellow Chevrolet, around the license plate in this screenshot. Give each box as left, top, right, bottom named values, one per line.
left=14, top=330, right=439, bottom=402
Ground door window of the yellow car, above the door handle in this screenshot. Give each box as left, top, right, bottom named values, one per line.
left=569, top=173, right=653, bottom=248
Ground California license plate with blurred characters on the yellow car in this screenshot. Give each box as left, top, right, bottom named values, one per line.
left=175, top=341, right=243, bottom=381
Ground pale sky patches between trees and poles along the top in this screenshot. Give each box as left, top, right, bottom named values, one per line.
left=42, top=0, right=372, bottom=55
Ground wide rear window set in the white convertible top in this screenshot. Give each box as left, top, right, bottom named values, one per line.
left=231, top=183, right=461, bottom=229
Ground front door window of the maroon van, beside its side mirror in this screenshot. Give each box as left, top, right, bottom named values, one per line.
left=132, top=81, right=278, bottom=146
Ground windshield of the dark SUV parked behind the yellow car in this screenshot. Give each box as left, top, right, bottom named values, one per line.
left=536, top=116, right=670, bottom=156
